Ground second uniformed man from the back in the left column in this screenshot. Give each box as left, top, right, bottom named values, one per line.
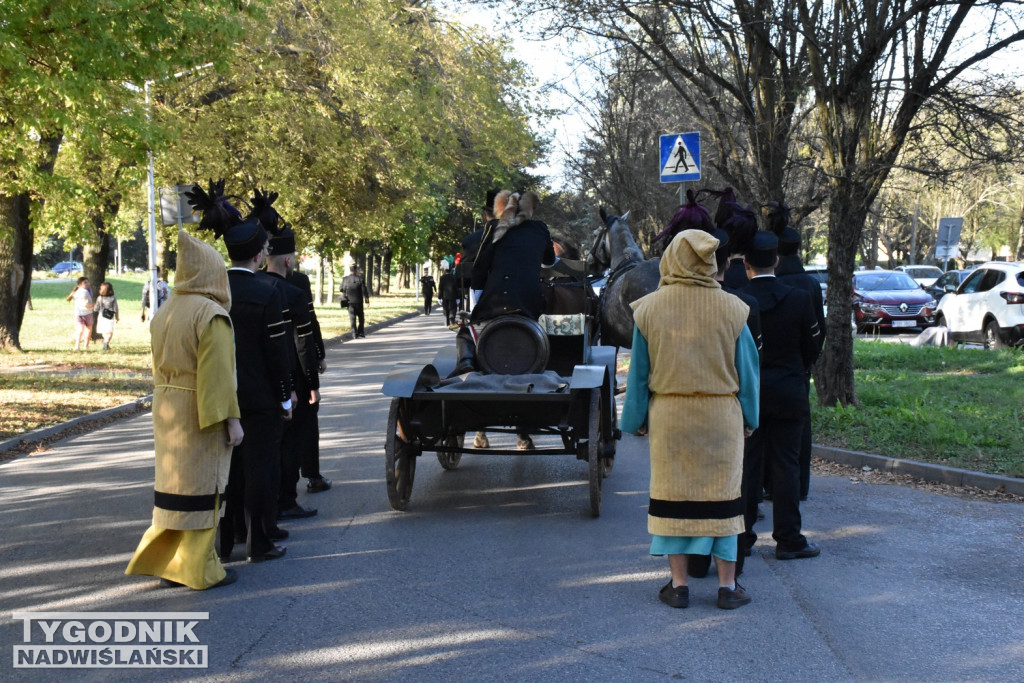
left=260, top=222, right=319, bottom=519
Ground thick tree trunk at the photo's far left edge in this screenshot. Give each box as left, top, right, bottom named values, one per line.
left=0, top=194, right=33, bottom=351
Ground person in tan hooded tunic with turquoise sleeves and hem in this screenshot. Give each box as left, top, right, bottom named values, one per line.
left=620, top=229, right=760, bottom=609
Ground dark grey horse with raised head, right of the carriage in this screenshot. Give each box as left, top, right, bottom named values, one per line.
left=588, top=208, right=662, bottom=348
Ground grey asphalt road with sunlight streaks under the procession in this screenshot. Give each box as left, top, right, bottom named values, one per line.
left=0, top=314, right=1024, bottom=682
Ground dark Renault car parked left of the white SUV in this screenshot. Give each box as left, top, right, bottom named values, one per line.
left=853, top=270, right=936, bottom=332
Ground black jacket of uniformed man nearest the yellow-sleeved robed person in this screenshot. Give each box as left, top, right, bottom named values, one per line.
left=227, top=269, right=292, bottom=414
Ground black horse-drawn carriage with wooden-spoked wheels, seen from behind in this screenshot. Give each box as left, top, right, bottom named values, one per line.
left=382, top=264, right=620, bottom=517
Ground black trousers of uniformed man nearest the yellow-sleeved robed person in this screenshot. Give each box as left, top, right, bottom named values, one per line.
left=217, top=412, right=284, bottom=557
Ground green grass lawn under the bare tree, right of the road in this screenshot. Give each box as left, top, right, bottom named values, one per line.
left=811, top=340, right=1024, bottom=477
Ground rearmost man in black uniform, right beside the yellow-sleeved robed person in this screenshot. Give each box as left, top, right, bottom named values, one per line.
left=220, top=220, right=292, bottom=562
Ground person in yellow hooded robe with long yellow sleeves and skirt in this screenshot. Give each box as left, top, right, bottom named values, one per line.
left=125, top=230, right=243, bottom=591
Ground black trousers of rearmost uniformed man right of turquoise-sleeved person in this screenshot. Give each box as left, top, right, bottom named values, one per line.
left=751, top=416, right=807, bottom=550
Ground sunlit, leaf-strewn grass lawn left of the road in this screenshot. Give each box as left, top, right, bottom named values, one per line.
left=0, top=274, right=420, bottom=440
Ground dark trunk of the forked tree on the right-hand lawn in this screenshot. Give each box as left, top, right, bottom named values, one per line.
left=816, top=183, right=869, bottom=407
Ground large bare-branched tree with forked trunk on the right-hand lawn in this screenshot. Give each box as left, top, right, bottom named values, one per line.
left=791, top=0, right=1024, bottom=405
